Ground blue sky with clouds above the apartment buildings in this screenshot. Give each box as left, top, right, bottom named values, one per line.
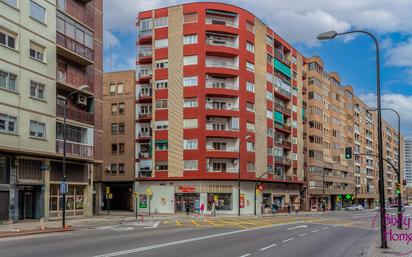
left=104, top=0, right=412, bottom=135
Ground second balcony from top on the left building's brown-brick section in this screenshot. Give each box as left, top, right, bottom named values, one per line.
left=56, top=32, right=94, bottom=66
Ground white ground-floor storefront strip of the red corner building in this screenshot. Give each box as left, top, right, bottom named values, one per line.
left=135, top=180, right=303, bottom=215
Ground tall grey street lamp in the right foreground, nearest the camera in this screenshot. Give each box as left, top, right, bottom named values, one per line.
left=317, top=30, right=388, bottom=248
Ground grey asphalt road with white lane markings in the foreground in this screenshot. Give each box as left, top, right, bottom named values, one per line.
left=0, top=213, right=375, bottom=257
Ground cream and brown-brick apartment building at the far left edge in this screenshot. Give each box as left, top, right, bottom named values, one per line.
left=0, top=0, right=103, bottom=221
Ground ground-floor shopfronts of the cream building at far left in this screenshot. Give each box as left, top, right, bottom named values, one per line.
left=0, top=152, right=93, bottom=222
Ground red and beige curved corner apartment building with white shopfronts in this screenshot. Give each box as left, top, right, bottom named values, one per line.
left=135, top=3, right=307, bottom=214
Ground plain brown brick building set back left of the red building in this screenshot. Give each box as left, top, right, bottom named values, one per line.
left=95, top=70, right=138, bottom=210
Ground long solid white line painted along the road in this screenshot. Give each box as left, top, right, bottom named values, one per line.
left=93, top=222, right=298, bottom=257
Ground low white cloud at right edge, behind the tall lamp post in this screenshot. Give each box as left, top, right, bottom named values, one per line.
left=359, top=93, right=412, bottom=135
